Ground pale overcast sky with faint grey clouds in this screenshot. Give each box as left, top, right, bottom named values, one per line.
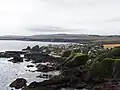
left=0, top=0, right=120, bottom=35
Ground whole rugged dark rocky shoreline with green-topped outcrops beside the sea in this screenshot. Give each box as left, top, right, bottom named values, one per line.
left=0, top=44, right=120, bottom=90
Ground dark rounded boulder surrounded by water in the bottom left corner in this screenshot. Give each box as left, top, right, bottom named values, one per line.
left=9, top=78, right=27, bottom=89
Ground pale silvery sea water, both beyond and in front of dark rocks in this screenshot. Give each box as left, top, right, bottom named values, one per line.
left=0, top=40, right=66, bottom=90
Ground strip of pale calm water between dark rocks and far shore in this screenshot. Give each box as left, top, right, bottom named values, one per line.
left=0, top=40, right=67, bottom=51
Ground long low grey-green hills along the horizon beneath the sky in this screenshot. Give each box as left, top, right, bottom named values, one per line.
left=0, top=34, right=120, bottom=43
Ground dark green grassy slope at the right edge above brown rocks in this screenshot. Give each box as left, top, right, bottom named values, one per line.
left=87, top=47, right=120, bottom=79
